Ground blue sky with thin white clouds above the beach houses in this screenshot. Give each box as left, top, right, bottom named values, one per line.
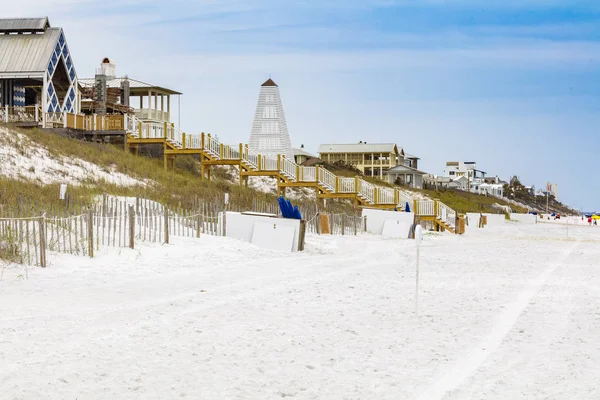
left=2, top=0, right=600, bottom=210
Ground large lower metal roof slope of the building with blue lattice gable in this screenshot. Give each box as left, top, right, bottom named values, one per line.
left=0, top=28, right=62, bottom=77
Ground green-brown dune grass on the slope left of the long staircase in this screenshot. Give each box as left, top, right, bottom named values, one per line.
left=0, top=128, right=351, bottom=214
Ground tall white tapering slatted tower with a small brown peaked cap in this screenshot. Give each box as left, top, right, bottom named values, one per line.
left=248, top=78, right=294, bottom=161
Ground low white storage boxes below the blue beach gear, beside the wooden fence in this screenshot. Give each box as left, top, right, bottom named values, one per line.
left=226, top=211, right=300, bottom=251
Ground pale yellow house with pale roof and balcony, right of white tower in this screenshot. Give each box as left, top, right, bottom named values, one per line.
left=319, top=142, right=405, bottom=180
